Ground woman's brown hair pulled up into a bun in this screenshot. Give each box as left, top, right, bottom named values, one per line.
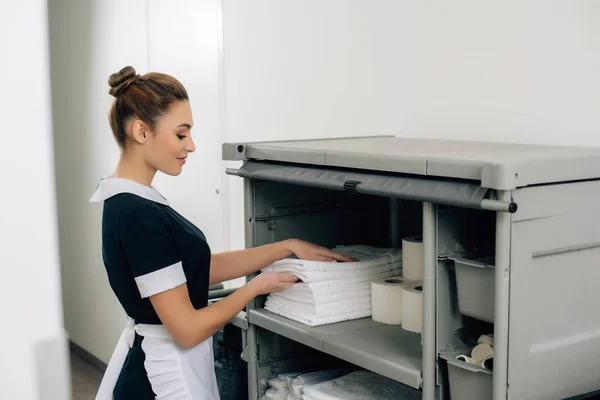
left=108, top=66, right=189, bottom=149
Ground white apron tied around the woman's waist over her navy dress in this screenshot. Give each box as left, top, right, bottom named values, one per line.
left=96, top=318, right=219, bottom=400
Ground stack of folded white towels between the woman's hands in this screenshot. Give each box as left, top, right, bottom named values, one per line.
left=263, top=245, right=402, bottom=326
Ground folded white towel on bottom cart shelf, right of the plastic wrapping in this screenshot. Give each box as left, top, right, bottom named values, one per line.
left=304, top=370, right=421, bottom=400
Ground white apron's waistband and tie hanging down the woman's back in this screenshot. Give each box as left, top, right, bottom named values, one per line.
left=96, top=317, right=172, bottom=400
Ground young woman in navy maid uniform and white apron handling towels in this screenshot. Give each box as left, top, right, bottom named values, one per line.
left=91, top=67, right=349, bottom=400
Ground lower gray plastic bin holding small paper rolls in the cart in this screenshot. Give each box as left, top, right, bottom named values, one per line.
left=440, top=349, right=493, bottom=400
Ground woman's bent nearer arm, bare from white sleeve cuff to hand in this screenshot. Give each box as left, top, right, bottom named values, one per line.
left=150, top=273, right=297, bottom=348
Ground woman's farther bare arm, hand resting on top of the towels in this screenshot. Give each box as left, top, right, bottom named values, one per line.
left=210, top=239, right=353, bottom=285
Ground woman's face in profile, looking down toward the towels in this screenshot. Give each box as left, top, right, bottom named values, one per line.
left=144, top=101, right=196, bottom=175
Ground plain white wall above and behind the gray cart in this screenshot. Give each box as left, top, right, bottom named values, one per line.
left=223, top=0, right=600, bottom=253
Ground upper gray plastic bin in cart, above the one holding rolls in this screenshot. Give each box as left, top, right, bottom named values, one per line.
left=451, top=257, right=495, bottom=323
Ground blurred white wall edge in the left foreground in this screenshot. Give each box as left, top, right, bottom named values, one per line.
left=0, top=0, right=70, bottom=400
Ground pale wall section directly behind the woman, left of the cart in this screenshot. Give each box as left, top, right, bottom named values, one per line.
left=50, top=0, right=226, bottom=362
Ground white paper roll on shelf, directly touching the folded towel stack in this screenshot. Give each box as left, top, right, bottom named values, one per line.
left=371, top=276, right=405, bottom=325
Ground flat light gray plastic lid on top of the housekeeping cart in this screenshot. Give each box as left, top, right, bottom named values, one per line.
left=223, top=136, right=600, bottom=190
